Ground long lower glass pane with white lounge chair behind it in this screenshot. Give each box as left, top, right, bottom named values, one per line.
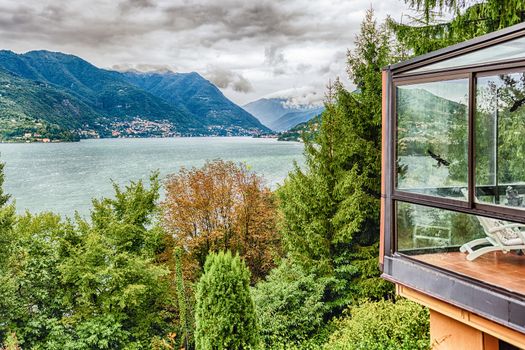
left=396, top=202, right=525, bottom=295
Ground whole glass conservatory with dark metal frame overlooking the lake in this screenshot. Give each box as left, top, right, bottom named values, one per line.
left=380, top=24, right=525, bottom=349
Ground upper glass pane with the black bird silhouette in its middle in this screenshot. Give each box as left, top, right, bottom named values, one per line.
left=396, top=79, right=468, bottom=201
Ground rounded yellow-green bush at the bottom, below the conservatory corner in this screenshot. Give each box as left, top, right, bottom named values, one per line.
left=325, top=299, right=430, bottom=350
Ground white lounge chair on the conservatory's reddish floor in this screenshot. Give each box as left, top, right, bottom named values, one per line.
left=459, top=190, right=525, bottom=261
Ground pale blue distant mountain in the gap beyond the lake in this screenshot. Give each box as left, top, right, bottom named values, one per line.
left=243, top=98, right=324, bottom=131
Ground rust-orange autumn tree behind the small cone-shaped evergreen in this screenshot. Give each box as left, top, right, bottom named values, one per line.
left=163, top=160, right=280, bottom=281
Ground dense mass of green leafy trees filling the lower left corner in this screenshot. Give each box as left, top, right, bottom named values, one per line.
left=0, top=172, right=176, bottom=349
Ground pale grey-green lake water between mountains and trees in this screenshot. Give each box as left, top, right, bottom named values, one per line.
left=0, top=137, right=304, bottom=216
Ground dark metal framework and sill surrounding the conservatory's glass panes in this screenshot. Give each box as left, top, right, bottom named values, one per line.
left=381, top=23, right=525, bottom=333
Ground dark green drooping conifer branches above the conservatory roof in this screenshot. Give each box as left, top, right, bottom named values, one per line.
left=389, top=0, right=525, bottom=55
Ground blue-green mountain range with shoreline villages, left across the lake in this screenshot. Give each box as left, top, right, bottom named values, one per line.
left=0, top=50, right=270, bottom=141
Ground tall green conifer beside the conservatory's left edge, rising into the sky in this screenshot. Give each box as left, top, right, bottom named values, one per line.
left=278, top=10, right=392, bottom=308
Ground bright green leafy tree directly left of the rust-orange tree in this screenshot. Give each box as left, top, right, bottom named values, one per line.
left=56, top=174, right=174, bottom=348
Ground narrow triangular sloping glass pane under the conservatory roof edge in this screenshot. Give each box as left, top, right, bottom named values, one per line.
left=410, top=37, right=525, bottom=73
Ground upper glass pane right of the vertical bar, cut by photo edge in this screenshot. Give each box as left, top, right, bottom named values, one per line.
left=475, top=73, right=525, bottom=209
